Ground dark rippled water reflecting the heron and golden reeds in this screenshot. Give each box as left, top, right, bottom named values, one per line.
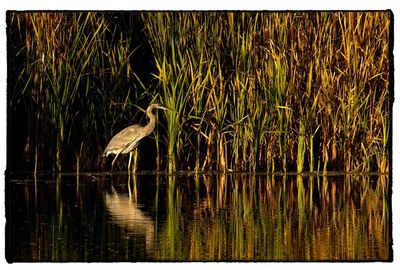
left=6, top=171, right=392, bottom=262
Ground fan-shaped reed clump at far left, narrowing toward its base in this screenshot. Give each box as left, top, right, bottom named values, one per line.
left=19, top=13, right=105, bottom=171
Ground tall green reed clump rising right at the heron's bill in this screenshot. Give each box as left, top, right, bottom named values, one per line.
left=142, top=14, right=195, bottom=172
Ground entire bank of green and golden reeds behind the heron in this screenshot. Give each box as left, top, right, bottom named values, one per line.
left=7, top=11, right=393, bottom=173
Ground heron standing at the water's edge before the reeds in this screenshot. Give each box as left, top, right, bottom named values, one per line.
left=103, top=103, right=171, bottom=172
